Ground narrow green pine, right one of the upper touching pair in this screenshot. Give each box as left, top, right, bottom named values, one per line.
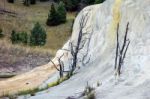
left=57, top=1, right=67, bottom=23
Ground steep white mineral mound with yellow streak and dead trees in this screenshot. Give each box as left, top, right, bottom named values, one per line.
left=28, top=0, right=150, bottom=99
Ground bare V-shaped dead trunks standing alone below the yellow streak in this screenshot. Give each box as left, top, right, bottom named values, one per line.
left=115, top=22, right=130, bottom=76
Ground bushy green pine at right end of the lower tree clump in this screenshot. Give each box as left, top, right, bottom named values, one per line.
left=30, top=22, right=46, bottom=46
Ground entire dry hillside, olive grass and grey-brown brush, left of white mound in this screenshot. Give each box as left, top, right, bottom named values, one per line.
left=0, top=0, right=75, bottom=72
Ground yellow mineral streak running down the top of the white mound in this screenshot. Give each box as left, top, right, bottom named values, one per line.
left=108, top=0, right=122, bottom=42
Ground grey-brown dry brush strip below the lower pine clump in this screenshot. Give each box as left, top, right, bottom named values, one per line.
left=0, top=39, right=55, bottom=76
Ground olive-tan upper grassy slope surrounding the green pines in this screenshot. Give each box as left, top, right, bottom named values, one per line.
left=0, top=0, right=75, bottom=50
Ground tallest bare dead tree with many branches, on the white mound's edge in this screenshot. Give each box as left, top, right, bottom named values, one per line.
left=69, top=13, right=90, bottom=76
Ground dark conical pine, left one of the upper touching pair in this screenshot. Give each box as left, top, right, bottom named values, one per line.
left=46, top=4, right=59, bottom=26
